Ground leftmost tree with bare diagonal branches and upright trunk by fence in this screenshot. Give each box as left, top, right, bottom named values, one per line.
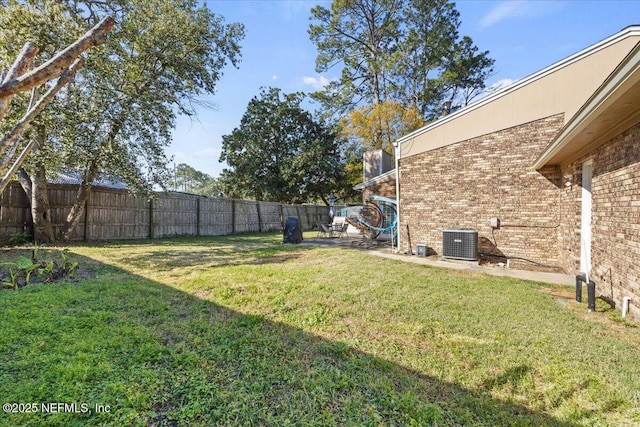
left=0, top=1, right=115, bottom=241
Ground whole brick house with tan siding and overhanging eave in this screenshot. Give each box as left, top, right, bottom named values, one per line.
left=388, top=26, right=640, bottom=319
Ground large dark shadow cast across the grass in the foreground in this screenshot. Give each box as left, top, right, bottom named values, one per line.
left=0, top=247, right=573, bottom=426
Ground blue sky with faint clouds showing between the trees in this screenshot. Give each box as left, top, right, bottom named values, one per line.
left=167, top=0, right=640, bottom=177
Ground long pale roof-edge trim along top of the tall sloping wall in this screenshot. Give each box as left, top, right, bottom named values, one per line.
left=394, top=25, right=640, bottom=151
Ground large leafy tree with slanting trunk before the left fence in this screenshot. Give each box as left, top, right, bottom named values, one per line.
left=1, top=0, right=244, bottom=239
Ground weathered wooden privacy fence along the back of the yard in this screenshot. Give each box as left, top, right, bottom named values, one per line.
left=0, top=182, right=329, bottom=242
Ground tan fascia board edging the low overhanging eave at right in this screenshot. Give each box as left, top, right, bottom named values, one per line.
left=533, top=38, right=640, bottom=170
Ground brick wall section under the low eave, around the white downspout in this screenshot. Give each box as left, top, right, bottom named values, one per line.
left=560, top=124, right=640, bottom=320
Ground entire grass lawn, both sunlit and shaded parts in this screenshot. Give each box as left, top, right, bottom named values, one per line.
left=0, top=234, right=640, bottom=426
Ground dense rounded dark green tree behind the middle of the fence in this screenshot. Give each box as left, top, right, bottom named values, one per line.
left=220, top=88, right=344, bottom=203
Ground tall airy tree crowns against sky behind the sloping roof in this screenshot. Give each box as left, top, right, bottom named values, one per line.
left=309, top=0, right=493, bottom=119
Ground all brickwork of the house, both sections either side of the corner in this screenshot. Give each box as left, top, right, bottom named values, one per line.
left=399, top=115, right=640, bottom=320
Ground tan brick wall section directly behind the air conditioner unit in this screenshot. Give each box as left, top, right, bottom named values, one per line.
left=400, top=114, right=563, bottom=269
